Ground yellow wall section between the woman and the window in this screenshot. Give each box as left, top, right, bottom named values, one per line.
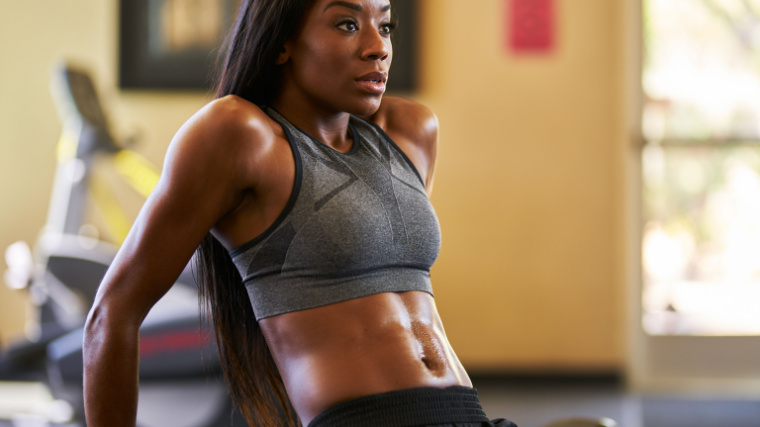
left=421, top=0, right=622, bottom=369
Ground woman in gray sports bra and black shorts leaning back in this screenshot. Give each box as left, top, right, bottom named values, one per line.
left=84, top=0, right=512, bottom=427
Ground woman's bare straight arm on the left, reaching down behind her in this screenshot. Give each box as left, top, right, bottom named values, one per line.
left=83, top=99, right=264, bottom=427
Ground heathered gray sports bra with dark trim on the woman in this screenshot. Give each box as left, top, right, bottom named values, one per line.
left=230, top=108, right=441, bottom=320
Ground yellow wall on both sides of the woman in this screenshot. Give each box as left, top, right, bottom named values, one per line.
left=0, top=0, right=624, bottom=370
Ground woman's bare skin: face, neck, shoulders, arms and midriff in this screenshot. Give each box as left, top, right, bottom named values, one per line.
left=84, top=0, right=471, bottom=427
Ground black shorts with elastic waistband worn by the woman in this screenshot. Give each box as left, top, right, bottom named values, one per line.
left=308, top=386, right=517, bottom=427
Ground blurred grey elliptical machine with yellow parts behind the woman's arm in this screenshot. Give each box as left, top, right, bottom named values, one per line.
left=0, top=65, right=247, bottom=427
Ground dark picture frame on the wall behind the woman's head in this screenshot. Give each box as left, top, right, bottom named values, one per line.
left=119, top=0, right=418, bottom=93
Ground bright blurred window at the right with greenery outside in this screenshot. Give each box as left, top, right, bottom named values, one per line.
left=642, top=0, right=760, bottom=335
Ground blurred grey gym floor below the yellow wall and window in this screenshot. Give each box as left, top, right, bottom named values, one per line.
left=0, top=375, right=760, bottom=427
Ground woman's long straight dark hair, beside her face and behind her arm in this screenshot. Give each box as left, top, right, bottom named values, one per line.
left=196, top=0, right=312, bottom=426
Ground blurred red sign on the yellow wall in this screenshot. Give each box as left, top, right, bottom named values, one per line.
left=505, top=0, right=555, bottom=53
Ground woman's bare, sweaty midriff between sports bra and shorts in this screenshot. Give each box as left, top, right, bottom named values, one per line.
left=259, top=292, right=472, bottom=425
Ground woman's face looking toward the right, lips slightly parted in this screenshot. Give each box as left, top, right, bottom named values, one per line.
left=278, top=0, right=393, bottom=116
